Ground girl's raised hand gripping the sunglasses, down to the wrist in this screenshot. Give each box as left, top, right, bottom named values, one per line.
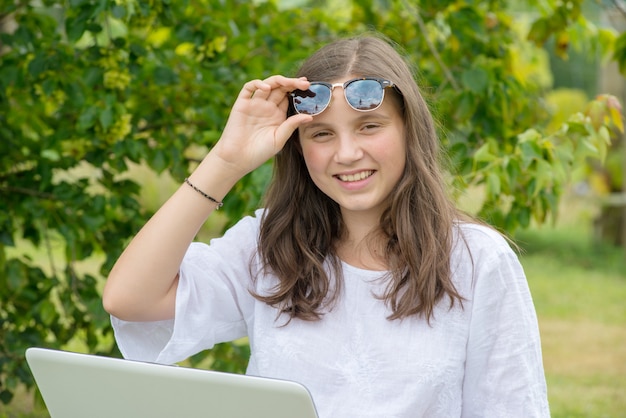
left=210, top=75, right=312, bottom=177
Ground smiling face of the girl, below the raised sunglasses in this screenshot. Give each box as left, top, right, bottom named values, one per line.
left=299, top=77, right=406, bottom=224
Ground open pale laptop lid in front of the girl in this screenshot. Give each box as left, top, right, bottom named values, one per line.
left=26, top=348, right=317, bottom=418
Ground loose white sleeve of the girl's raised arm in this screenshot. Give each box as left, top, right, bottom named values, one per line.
left=111, top=211, right=258, bottom=364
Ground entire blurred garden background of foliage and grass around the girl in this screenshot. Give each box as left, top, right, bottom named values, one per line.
left=0, top=0, right=626, bottom=418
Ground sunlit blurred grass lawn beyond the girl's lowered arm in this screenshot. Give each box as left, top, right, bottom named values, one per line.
left=0, top=193, right=626, bottom=418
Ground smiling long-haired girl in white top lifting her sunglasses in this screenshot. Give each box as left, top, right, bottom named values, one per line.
left=104, top=37, right=549, bottom=418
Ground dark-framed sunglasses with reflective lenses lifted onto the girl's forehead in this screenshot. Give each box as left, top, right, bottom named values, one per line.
left=290, top=77, right=394, bottom=115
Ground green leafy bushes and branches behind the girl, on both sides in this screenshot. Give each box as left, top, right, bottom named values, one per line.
left=0, top=0, right=623, bottom=402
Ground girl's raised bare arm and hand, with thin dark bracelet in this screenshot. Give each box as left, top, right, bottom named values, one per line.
left=103, top=76, right=312, bottom=321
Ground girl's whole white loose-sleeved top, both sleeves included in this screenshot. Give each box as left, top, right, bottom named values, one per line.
left=112, top=212, right=550, bottom=418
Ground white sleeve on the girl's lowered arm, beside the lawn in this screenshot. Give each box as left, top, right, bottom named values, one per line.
left=462, top=227, right=550, bottom=418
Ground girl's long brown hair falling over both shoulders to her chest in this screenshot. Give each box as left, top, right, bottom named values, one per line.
left=255, top=36, right=462, bottom=321
